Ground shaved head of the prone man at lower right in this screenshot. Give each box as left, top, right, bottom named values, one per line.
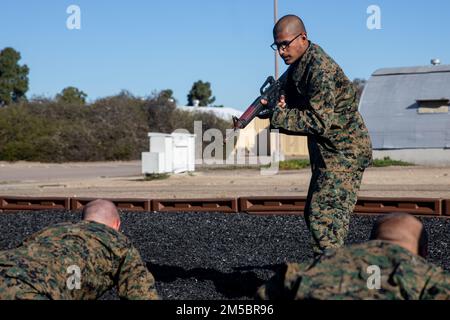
left=370, top=213, right=428, bottom=257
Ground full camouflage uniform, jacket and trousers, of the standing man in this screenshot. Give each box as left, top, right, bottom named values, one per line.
left=271, top=17, right=372, bottom=255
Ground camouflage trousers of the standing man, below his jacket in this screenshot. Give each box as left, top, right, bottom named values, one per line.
left=305, top=169, right=364, bottom=256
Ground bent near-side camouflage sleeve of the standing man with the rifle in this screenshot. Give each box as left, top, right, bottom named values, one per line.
left=272, top=70, right=335, bottom=136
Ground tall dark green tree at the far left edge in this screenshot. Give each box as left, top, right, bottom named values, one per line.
left=0, top=48, right=30, bottom=106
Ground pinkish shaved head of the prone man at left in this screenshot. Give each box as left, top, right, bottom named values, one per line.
left=83, top=199, right=120, bottom=231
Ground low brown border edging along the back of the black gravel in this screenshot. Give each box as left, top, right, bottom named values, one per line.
left=0, top=196, right=450, bottom=217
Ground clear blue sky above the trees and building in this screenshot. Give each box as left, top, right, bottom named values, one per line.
left=0, top=0, right=450, bottom=110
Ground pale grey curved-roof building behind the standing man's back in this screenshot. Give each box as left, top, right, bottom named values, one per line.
left=359, top=61, right=450, bottom=165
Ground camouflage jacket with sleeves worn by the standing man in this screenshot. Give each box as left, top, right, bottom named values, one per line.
left=271, top=42, right=372, bottom=171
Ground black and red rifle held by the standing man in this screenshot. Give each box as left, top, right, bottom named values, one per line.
left=225, top=71, right=288, bottom=142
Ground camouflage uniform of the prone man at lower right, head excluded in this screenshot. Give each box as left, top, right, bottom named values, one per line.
left=258, top=240, right=450, bottom=300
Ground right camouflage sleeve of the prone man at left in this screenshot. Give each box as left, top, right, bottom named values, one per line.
left=117, top=247, right=159, bottom=300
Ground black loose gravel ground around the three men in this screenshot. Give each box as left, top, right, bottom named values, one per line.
left=0, top=211, right=450, bottom=299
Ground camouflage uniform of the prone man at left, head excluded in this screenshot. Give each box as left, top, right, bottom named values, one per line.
left=0, top=221, right=158, bottom=300
